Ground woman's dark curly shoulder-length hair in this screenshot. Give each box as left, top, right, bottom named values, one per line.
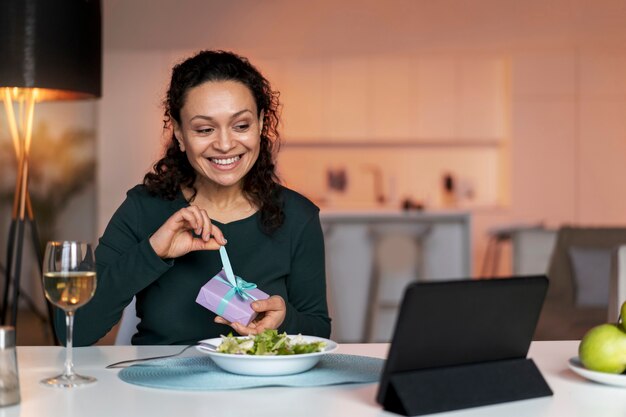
left=143, top=51, right=284, bottom=233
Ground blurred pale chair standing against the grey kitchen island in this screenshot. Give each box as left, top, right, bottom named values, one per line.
left=363, top=223, right=431, bottom=342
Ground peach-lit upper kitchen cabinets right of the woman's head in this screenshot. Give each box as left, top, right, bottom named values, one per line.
left=270, top=54, right=509, bottom=146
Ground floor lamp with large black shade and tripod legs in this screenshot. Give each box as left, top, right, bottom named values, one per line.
left=0, top=0, right=102, bottom=335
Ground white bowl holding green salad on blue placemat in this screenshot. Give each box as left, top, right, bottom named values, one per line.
left=196, top=335, right=337, bottom=376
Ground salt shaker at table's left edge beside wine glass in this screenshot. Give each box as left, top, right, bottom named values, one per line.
left=0, top=326, right=20, bottom=407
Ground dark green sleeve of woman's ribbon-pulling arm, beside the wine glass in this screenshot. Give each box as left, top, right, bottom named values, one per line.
left=56, top=193, right=171, bottom=346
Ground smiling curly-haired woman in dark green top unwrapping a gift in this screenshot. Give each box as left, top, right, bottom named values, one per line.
left=57, top=51, right=330, bottom=345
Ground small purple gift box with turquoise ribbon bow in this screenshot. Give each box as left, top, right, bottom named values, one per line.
left=196, top=269, right=269, bottom=326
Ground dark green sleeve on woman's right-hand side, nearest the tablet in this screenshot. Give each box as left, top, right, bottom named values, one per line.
left=280, top=213, right=330, bottom=338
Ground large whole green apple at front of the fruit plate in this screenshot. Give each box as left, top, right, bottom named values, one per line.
left=578, top=324, right=626, bottom=374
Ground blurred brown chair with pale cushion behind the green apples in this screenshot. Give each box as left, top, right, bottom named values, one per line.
left=535, top=226, right=626, bottom=340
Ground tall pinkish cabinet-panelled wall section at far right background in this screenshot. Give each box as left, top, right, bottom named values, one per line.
left=511, top=45, right=626, bottom=225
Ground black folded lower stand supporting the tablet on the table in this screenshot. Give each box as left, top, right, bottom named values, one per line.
left=382, top=358, right=552, bottom=416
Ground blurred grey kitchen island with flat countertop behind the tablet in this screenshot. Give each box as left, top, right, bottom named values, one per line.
left=321, top=210, right=472, bottom=343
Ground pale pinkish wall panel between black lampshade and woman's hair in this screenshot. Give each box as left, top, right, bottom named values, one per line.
left=97, top=51, right=171, bottom=231
